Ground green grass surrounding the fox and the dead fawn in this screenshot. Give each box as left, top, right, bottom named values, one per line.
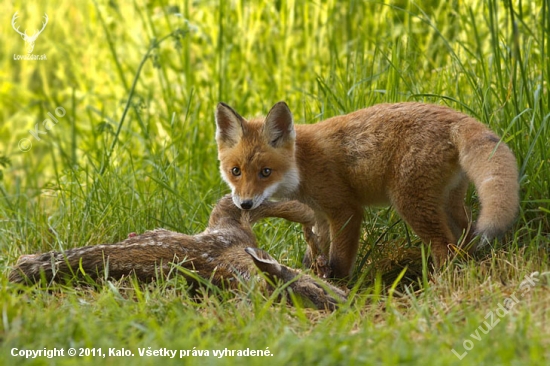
left=0, top=0, right=550, bottom=365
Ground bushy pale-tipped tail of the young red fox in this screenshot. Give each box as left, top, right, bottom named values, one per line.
left=453, top=117, right=519, bottom=240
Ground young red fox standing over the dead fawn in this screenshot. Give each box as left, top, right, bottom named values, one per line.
left=216, top=102, right=519, bottom=278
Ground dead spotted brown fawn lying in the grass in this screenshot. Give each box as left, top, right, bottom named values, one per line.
left=9, top=195, right=347, bottom=310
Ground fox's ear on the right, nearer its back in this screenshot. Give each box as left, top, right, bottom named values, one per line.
left=264, top=102, right=296, bottom=147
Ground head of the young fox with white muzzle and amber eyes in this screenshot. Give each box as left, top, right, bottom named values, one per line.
left=216, top=102, right=299, bottom=210
